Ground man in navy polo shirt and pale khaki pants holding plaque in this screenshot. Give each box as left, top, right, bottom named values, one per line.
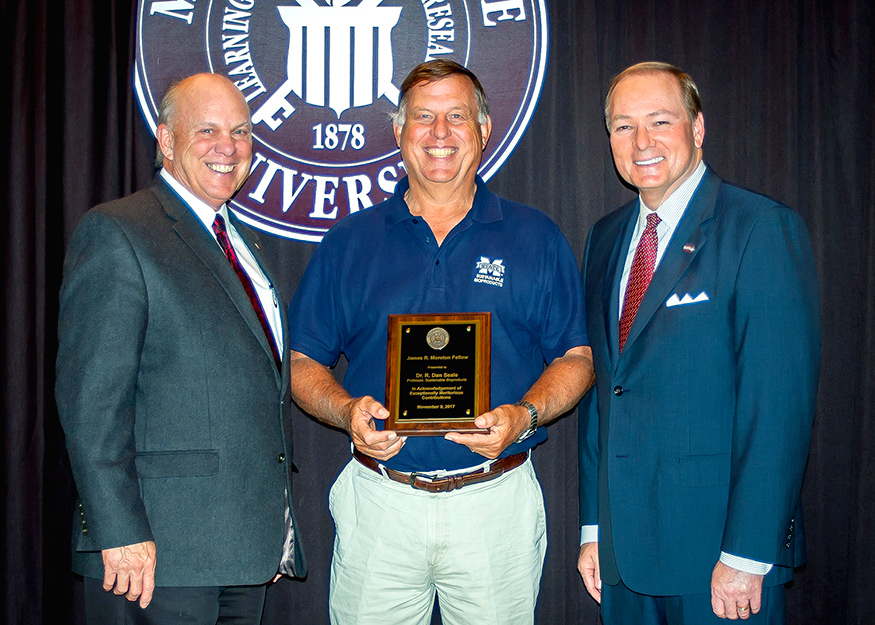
left=289, top=60, right=593, bottom=625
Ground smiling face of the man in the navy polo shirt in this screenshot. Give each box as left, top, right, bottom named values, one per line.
left=394, top=74, right=492, bottom=197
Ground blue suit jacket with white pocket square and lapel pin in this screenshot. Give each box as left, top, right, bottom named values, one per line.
left=580, top=169, right=820, bottom=595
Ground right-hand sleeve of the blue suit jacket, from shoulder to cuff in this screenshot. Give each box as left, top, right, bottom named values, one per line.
left=721, top=207, right=820, bottom=566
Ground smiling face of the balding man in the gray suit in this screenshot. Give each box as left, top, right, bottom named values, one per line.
left=157, top=74, right=252, bottom=210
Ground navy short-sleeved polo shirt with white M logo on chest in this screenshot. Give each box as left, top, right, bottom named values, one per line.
left=289, top=177, right=589, bottom=471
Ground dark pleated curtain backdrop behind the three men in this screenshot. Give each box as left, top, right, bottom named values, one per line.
left=0, top=0, right=875, bottom=625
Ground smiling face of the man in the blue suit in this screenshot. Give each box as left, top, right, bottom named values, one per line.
left=609, top=72, right=705, bottom=210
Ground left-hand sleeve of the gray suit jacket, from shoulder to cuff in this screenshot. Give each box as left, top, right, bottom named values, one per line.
left=56, top=211, right=152, bottom=551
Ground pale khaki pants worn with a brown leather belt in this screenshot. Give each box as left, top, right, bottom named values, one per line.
left=329, top=460, right=547, bottom=625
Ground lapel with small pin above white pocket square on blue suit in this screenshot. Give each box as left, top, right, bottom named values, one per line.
left=615, top=169, right=722, bottom=351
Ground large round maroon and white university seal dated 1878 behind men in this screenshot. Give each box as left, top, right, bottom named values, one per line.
left=134, top=0, right=547, bottom=242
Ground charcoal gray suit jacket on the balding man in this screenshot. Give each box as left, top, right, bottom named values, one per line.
left=56, top=177, right=306, bottom=586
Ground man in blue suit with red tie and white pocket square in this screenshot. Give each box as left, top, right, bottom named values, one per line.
left=578, top=63, right=820, bottom=625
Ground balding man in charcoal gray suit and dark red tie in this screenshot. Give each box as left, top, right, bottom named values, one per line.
left=56, top=74, right=306, bottom=625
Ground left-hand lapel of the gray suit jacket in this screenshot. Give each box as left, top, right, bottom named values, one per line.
left=152, top=177, right=285, bottom=378
